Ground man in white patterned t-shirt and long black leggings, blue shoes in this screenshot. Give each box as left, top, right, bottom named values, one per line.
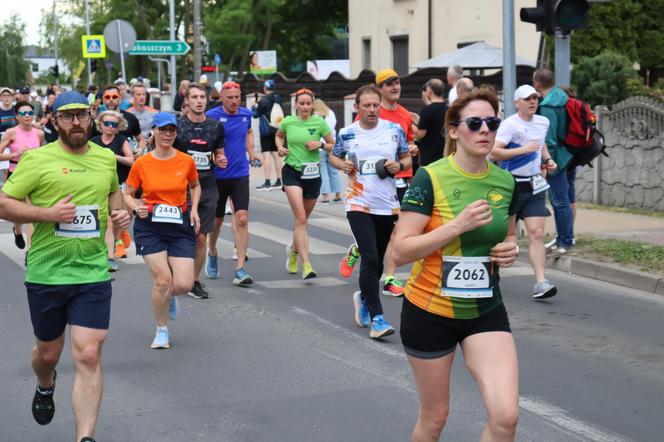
left=330, top=85, right=412, bottom=339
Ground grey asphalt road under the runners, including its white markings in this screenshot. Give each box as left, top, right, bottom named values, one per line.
left=0, top=191, right=664, bottom=442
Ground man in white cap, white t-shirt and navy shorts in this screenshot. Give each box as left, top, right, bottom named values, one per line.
left=490, top=84, right=558, bottom=299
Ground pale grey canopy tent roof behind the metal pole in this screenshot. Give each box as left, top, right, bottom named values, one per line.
left=415, top=41, right=535, bottom=69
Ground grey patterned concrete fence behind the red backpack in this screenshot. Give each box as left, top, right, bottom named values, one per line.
left=576, top=97, right=664, bottom=211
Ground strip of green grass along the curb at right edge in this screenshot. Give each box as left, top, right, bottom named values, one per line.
left=574, top=235, right=664, bottom=274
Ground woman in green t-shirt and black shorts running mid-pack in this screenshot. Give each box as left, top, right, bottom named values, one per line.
left=275, top=89, right=334, bottom=279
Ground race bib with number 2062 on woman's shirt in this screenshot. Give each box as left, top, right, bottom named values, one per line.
left=441, top=256, right=493, bottom=298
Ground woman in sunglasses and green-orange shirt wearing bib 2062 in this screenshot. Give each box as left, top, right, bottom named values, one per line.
left=394, top=89, right=519, bottom=441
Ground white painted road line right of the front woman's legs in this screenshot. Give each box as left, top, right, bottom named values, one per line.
left=519, top=396, right=632, bottom=442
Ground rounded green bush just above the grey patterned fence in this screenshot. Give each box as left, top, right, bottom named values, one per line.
left=572, top=50, right=638, bottom=107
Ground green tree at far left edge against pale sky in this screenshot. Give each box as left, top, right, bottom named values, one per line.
left=0, top=14, right=30, bottom=88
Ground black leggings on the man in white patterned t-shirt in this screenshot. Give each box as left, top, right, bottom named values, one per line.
left=346, top=212, right=398, bottom=318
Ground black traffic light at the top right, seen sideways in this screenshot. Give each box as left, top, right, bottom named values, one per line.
left=520, top=0, right=589, bottom=34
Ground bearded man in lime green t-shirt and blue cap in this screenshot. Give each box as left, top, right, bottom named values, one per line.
left=0, top=92, right=130, bottom=440
